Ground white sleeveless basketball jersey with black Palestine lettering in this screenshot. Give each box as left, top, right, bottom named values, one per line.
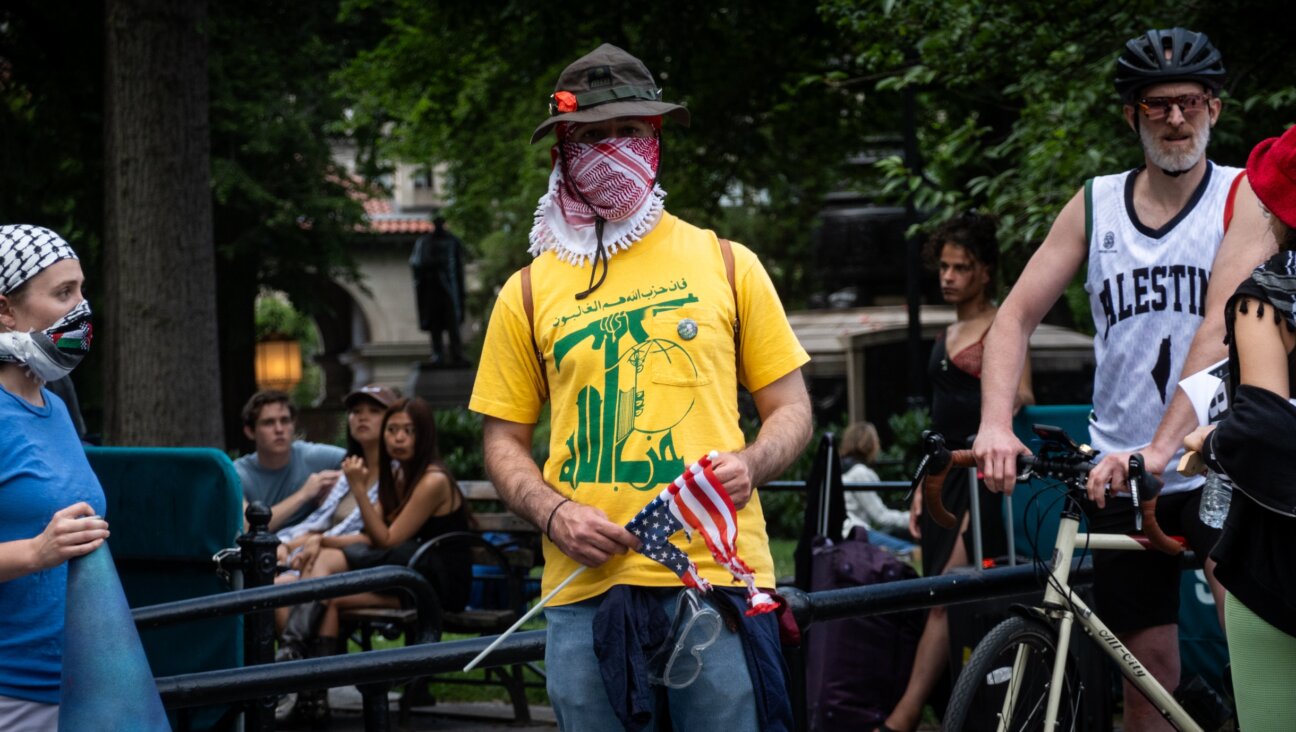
left=1085, top=162, right=1242, bottom=492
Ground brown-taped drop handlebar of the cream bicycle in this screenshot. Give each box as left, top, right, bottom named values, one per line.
left=914, top=433, right=1183, bottom=555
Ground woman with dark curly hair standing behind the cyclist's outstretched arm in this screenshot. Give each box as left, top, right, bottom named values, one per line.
left=879, top=211, right=1034, bottom=732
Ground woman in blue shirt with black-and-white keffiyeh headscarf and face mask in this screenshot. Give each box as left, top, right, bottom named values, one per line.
left=0, top=225, right=108, bottom=731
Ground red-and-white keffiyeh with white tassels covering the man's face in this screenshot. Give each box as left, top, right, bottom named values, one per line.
left=529, top=137, right=666, bottom=266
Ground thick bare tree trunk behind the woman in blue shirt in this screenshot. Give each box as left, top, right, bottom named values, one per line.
left=104, top=0, right=224, bottom=447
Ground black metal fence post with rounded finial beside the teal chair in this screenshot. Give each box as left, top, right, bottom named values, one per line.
left=236, top=501, right=279, bottom=732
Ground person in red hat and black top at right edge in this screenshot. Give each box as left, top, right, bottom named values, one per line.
left=1183, top=128, right=1296, bottom=729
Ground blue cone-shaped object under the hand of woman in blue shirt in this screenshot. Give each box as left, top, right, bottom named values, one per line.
left=58, top=544, right=171, bottom=732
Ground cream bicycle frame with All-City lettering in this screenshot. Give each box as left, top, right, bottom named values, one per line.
left=999, top=508, right=1201, bottom=732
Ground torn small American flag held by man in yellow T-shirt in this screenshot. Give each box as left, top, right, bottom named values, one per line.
left=626, top=452, right=778, bottom=615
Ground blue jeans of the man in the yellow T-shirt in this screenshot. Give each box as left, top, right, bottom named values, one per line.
left=544, top=589, right=759, bottom=732
